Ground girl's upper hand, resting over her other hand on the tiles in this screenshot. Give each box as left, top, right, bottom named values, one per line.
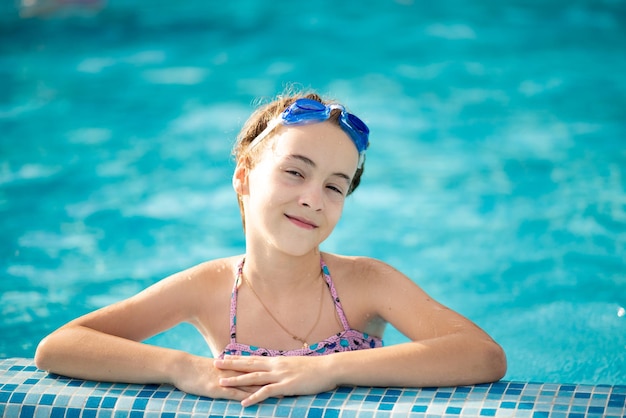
left=214, top=356, right=336, bottom=407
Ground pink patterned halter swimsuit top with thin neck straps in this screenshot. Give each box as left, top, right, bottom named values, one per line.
left=220, top=259, right=383, bottom=358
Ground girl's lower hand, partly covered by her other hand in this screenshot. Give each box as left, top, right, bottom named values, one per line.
left=168, top=355, right=260, bottom=401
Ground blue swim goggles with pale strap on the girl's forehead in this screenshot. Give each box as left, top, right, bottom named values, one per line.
left=249, top=98, right=370, bottom=168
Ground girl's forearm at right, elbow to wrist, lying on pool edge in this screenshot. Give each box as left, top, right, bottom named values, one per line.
left=327, top=334, right=506, bottom=387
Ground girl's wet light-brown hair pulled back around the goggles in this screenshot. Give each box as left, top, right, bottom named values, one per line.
left=232, top=92, right=365, bottom=229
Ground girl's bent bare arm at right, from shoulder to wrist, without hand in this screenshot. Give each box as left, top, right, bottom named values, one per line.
left=328, top=261, right=506, bottom=387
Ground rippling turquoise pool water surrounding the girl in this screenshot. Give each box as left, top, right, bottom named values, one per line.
left=0, top=0, right=626, bottom=384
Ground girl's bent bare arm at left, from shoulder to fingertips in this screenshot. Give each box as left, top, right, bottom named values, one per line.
left=35, top=262, right=248, bottom=399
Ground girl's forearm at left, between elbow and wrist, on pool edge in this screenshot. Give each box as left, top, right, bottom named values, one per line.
left=35, top=326, right=186, bottom=383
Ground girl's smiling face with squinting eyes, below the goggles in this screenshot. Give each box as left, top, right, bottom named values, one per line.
left=233, top=122, right=358, bottom=255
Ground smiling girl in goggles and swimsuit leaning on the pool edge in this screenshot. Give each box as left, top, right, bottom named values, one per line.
left=35, top=93, right=506, bottom=406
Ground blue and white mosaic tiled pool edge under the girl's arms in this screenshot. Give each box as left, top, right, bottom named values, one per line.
left=0, top=358, right=626, bottom=418
